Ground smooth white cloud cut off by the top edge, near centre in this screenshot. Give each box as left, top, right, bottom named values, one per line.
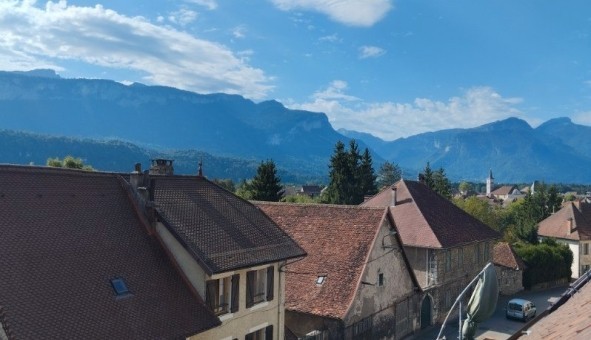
left=271, top=0, right=393, bottom=27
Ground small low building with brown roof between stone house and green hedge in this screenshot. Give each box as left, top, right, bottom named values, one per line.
left=493, top=242, right=525, bottom=295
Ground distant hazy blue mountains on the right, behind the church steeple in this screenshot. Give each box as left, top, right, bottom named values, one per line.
left=341, top=118, right=591, bottom=183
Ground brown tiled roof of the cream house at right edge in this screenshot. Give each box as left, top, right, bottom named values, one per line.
left=538, top=202, right=591, bottom=240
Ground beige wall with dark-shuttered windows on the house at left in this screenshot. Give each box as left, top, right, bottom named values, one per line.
left=156, top=223, right=285, bottom=340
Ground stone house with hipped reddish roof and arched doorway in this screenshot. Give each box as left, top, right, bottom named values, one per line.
left=362, top=180, right=500, bottom=328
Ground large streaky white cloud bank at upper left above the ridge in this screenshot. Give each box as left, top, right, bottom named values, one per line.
left=0, top=1, right=272, bottom=99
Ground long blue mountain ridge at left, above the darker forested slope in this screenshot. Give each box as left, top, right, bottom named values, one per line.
left=0, top=70, right=381, bottom=182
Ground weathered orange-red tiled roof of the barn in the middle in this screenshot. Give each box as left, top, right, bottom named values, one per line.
left=256, top=202, right=386, bottom=319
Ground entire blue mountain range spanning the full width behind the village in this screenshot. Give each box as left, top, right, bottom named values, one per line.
left=0, top=70, right=591, bottom=183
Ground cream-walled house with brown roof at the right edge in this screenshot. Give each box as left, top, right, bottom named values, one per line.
left=538, top=200, right=591, bottom=279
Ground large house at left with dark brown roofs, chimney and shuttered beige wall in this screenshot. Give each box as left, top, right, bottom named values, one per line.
left=0, top=160, right=305, bottom=340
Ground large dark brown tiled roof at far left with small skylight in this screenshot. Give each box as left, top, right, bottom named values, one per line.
left=0, top=166, right=219, bottom=339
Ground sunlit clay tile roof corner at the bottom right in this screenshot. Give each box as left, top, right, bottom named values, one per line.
left=520, top=282, right=591, bottom=340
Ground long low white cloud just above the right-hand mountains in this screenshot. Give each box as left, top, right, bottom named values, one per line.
left=287, top=81, right=525, bottom=140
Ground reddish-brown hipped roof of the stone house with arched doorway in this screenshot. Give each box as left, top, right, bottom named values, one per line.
left=362, top=180, right=500, bottom=248
